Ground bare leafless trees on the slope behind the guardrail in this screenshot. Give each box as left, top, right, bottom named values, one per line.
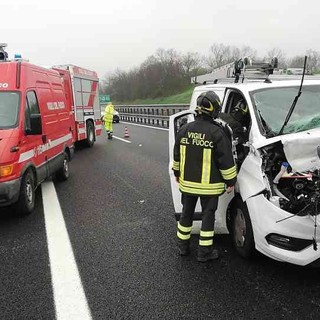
left=100, top=43, right=320, bottom=102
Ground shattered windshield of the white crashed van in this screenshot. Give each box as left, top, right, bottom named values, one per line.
left=251, top=85, right=320, bottom=135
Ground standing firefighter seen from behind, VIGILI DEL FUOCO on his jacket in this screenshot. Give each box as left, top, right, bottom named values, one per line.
left=172, top=91, right=237, bottom=262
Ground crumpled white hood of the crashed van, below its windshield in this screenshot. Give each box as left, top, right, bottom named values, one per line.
left=254, top=128, right=320, bottom=172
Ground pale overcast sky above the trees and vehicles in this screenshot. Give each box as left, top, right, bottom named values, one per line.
left=0, top=0, right=320, bottom=77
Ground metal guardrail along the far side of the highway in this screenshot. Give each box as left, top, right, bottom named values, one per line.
left=101, top=104, right=189, bottom=128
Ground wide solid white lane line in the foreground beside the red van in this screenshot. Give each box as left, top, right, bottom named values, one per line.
left=41, top=181, right=92, bottom=320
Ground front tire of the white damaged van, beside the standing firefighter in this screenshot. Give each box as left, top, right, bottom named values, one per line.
left=231, top=197, right=255, bottom=258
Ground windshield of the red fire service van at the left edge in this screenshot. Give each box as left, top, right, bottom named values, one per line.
left=0, top=92, right=19, bottom=130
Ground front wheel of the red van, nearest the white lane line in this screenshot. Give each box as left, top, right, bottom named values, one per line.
left=17, top=170, right=35, bottom=215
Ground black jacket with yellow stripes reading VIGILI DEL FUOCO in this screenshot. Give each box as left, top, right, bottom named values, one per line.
left=172, top=116, right=237, bottom=196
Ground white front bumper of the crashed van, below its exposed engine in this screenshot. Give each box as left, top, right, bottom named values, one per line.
left=246, top=195, right=320, bottom=266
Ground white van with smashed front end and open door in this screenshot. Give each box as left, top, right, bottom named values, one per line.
left=169, top=64, right=320, bottom=265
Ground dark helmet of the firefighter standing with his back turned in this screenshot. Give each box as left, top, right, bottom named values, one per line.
left=196, top=91, right=221, bottom=119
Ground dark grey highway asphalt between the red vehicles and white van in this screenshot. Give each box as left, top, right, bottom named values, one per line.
left=0, top=123, right=320, bottom=320
